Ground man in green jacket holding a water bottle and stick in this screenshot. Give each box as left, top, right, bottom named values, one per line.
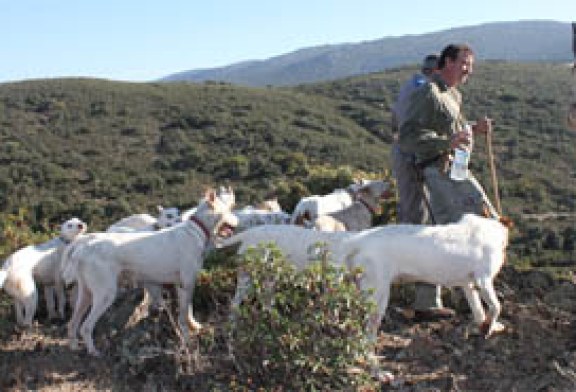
left=399, top=44, right=498, bottom=318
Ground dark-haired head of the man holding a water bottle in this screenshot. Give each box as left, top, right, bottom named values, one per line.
left=438, top=44, right=474, bottom=86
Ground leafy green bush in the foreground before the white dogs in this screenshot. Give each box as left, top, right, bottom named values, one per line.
left=230, top=245, right=374, bottom=391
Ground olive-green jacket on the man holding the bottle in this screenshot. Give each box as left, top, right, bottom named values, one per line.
left=398, top=75, right=466, bottom=162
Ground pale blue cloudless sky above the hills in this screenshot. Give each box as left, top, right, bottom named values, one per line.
left=0, top=0, right=576, bottom=83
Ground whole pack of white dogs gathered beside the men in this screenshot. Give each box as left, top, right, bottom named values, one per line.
left=0, top=180, right=510, bottom=374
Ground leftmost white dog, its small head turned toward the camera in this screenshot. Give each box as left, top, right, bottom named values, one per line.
left=0, top=218, right=87, bottom=326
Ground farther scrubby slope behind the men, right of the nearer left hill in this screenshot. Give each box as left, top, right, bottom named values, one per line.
left=297, top=62, right=576, bottom=214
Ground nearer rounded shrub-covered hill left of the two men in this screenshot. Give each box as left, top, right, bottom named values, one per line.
left=0, top=80, right=386, bottom=230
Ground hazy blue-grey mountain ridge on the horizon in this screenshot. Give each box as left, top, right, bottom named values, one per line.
left=162, top=21, right=572, bottom=86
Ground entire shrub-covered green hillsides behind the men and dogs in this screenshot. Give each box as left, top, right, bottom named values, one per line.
left=0, top=62, right=576, bottom=259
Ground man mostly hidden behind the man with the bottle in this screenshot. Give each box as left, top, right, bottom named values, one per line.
left=392, top=54, right=438, bottom=224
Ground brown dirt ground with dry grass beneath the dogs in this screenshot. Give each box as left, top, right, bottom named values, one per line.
left=0, top=267, right=576, bottom=392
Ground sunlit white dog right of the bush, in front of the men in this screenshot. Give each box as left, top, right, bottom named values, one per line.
left=348, top=214, right=512, bottom=337
